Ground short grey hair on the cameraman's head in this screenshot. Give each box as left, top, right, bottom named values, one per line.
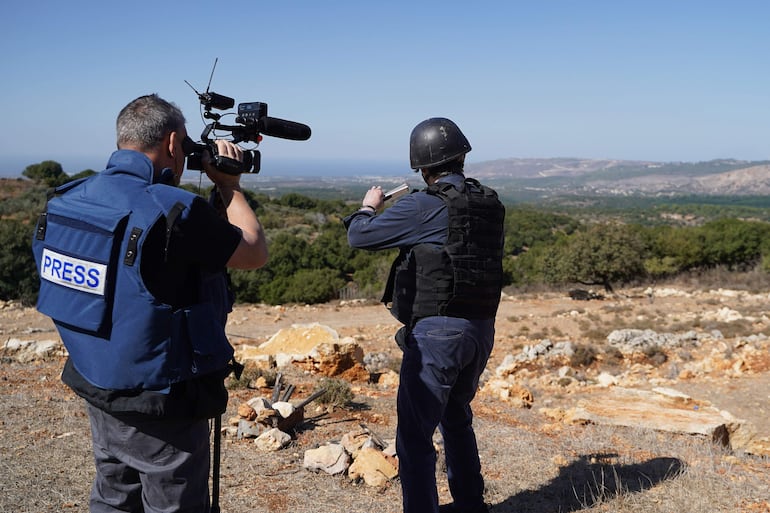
left=116, top=94, right=185, bottom=151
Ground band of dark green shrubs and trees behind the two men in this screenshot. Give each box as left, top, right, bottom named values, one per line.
left=0, top=161, right=770, bottom=304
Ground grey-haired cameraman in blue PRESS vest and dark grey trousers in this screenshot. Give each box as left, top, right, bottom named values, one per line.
left=33, top=94, right=268, bottom=513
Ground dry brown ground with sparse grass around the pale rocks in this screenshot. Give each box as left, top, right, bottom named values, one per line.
left=0, top=290, right=770, bottom=513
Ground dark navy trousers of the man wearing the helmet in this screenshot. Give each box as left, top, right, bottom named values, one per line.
left=396, top=317, right=494, bottom=513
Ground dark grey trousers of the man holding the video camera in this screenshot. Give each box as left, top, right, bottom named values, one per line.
left=88, top=405, right=210, bottom=513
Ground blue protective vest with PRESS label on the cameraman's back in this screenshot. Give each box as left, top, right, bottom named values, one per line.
left=32, top=150, right=233, bottom=392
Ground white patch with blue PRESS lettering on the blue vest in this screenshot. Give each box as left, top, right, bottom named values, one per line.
left=40, top=248, right=107, bottom=296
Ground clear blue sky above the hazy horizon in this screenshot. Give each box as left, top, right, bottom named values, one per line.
left=0, top=0, right=770, bottom=176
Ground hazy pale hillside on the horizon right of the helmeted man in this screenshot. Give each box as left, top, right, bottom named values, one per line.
left=467, top=158, right=770, bottom=196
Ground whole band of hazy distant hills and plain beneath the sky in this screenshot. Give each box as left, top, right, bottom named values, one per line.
left=10, top=158, right=770, bottom=208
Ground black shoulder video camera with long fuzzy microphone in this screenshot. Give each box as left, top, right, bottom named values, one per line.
left=182, top=81, right=310, bottom=175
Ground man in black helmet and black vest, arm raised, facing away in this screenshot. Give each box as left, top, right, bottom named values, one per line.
left=344, top=118, right=505, bottom=513
